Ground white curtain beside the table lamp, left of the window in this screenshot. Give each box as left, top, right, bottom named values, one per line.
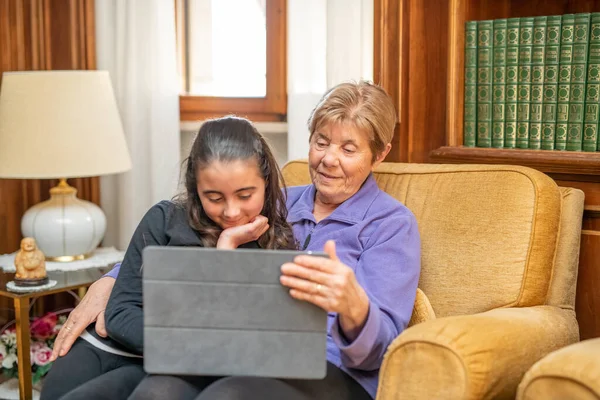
left=95, top=0, right=180, bottom=250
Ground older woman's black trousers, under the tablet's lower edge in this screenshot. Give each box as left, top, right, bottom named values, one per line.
left=129, top=363, right=372, bottom=400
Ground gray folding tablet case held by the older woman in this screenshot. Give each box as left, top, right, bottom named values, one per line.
left=142, top=246, right=327, bottom=379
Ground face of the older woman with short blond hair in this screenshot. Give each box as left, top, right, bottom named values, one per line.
left=308, top=123, right=389, bottom=205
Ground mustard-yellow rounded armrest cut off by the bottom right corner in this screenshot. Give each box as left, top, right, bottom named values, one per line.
left=517, top=338, right=600, bottom=400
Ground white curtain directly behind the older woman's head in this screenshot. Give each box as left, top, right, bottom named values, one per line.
left=288, top=0, right=373, bottom=160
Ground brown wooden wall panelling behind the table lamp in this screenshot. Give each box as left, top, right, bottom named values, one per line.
left=0, top=0, right=100, bottom=254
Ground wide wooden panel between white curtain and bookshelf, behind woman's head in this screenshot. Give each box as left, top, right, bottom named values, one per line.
left=374, top=0, right=449, bottom=162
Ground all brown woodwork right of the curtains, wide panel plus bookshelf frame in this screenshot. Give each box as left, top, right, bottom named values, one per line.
left=374, top=0, right=600, bottom=338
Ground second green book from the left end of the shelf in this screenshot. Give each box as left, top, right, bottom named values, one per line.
left=477, top=20, right=493, bottom=147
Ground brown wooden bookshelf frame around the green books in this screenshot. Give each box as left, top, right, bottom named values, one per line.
left=428, top=0, right=600, bottom=339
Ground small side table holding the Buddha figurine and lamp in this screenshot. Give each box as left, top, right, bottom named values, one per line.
left=0, top=266, right=112, bottom=400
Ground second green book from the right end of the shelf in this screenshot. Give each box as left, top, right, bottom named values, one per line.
left=567, top=13, right=590, bottom=151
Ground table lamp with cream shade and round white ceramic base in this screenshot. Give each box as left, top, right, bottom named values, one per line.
left=0, top=71, right=131, bottom=261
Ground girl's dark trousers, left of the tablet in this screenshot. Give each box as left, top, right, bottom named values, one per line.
left=40, top=339, right=147, bottom=400
